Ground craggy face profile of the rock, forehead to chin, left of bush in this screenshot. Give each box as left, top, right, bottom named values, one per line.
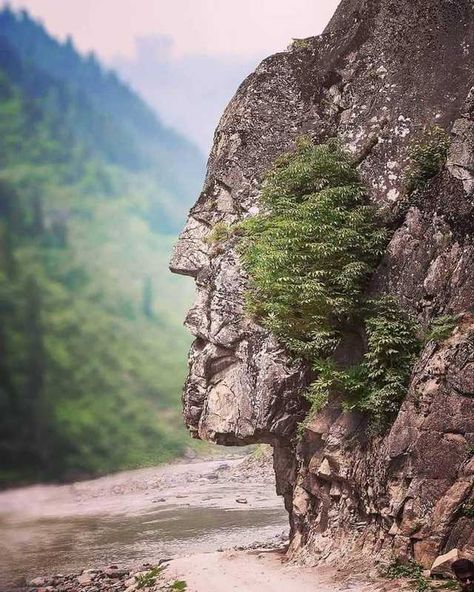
left=170, top=48, right=324, bottom=445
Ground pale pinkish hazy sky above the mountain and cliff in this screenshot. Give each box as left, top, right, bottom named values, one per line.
left=10, top=0, right=339, bottom=151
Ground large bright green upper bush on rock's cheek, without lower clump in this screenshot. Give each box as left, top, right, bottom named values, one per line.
left=241, top=139, right=386, bottom=360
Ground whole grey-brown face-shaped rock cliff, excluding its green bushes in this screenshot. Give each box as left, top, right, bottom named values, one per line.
left=171, top=0, right=474, bottom=567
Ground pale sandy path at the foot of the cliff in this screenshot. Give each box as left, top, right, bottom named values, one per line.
left=167, top=551, right=392, bottom=592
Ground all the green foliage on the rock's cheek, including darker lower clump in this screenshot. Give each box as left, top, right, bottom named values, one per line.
left=240, top=139, right=418, bottom=428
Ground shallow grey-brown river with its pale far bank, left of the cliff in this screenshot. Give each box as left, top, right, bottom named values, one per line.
left=0, top=461, right=287, bottom=589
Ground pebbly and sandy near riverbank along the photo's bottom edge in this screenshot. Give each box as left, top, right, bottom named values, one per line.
left=15, top=549, right=407, bottom=592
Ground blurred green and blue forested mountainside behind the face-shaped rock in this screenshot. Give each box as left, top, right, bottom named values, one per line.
left=0, top=9, right=203, bottom=483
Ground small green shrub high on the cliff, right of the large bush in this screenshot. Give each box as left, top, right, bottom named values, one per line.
left=405, top=125, right=451, bottom=194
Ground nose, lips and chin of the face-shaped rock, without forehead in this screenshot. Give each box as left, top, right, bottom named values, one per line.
left=171, top=202, right=312, bottom=444
